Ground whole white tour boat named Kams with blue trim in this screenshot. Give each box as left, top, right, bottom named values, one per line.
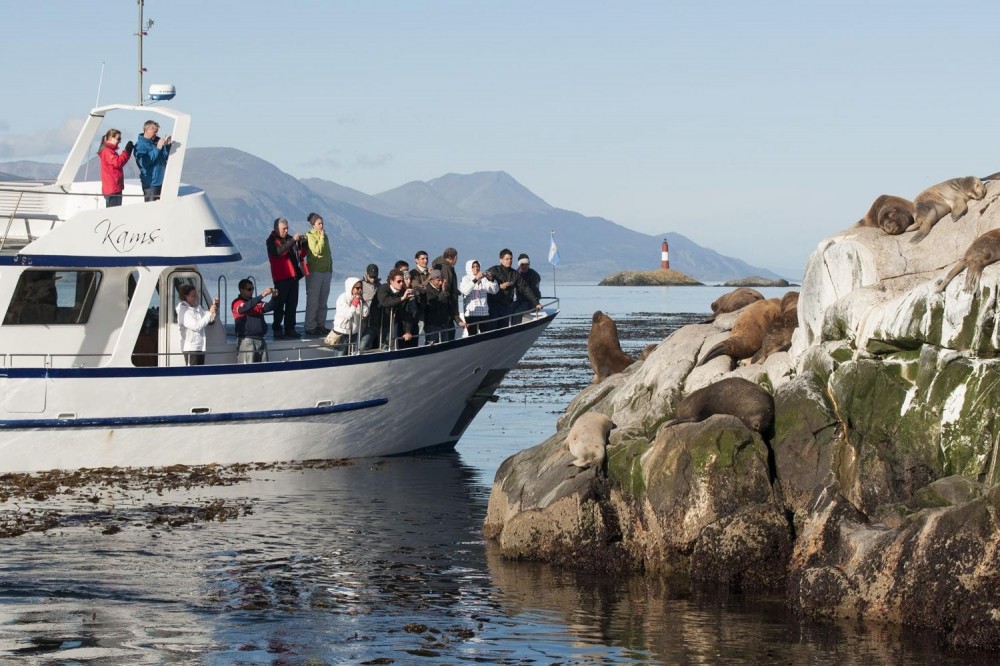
left=0, top=105, right=558, bottom=472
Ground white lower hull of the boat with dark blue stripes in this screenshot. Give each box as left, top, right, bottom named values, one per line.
left=0, top=315, right=553, bottom=472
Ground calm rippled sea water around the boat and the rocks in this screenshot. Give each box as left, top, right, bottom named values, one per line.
left=0, top=280, right=990, bottom=664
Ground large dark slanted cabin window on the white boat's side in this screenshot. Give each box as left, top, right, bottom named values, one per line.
left=3, top=270, right=101, bottom=326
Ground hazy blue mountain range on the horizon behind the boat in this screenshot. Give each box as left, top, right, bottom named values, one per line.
left=0, top=148, right=780, bottom=283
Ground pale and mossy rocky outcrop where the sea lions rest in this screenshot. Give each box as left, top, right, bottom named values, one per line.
left=485, top=183, right=1000, bottom=649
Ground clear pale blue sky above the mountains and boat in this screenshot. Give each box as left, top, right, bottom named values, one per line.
left=0, top=0, right=1000, bottom=269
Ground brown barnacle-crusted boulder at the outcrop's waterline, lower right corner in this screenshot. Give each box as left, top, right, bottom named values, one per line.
left=788, top=486, right=1000, bottom=649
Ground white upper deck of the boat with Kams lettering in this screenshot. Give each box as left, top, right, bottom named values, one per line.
left=0, top=104, right=241, bottom=267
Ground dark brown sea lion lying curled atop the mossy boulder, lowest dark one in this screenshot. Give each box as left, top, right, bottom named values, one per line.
left=666, top=377, right=774, bottom=432
